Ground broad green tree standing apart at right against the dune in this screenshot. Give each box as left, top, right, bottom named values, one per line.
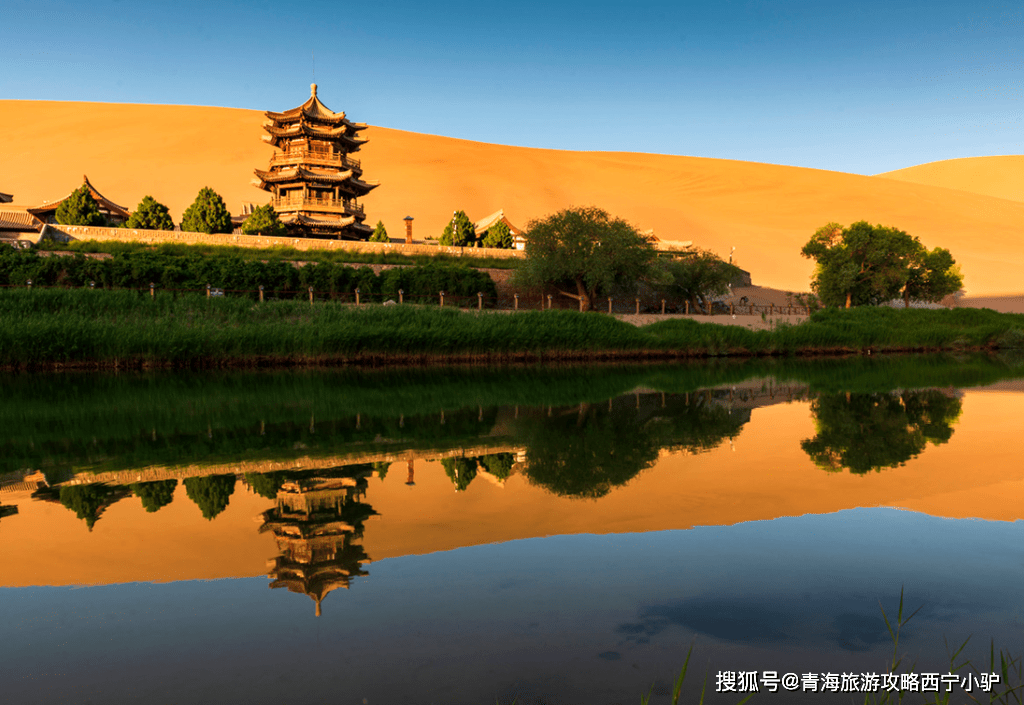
left=801, top=220, right=946, bottom=308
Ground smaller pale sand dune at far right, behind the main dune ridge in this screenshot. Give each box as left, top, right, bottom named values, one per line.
left=879, top=155, right=1024, bottom=203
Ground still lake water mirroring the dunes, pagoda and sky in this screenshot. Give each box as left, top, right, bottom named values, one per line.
left=0, top=357, right=1024, bottom=705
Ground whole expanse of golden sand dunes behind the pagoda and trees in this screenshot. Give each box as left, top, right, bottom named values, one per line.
left=0, top=99, right=1024, bottom=296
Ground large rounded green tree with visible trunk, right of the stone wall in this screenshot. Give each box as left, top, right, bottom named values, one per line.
left=516, top=207, right=655, bottom=310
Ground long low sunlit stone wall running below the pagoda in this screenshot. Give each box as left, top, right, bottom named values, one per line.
left=42, top=224, right=523, bottom=259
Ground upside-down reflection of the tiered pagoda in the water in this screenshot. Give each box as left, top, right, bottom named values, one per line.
left=259, top=464, right=377, bottom=617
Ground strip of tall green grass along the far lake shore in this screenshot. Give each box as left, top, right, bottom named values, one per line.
left=0, top=289, right=1024, bottom=369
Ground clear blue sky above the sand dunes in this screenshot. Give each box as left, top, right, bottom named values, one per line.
left=0, top=0, right=1024, bottom=174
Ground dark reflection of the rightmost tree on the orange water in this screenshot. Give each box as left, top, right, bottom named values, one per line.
left=800, top=389, right=963, bottom=473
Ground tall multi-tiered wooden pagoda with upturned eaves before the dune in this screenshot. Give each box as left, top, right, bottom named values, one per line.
left=253, top=83, right=379, bottom=240
